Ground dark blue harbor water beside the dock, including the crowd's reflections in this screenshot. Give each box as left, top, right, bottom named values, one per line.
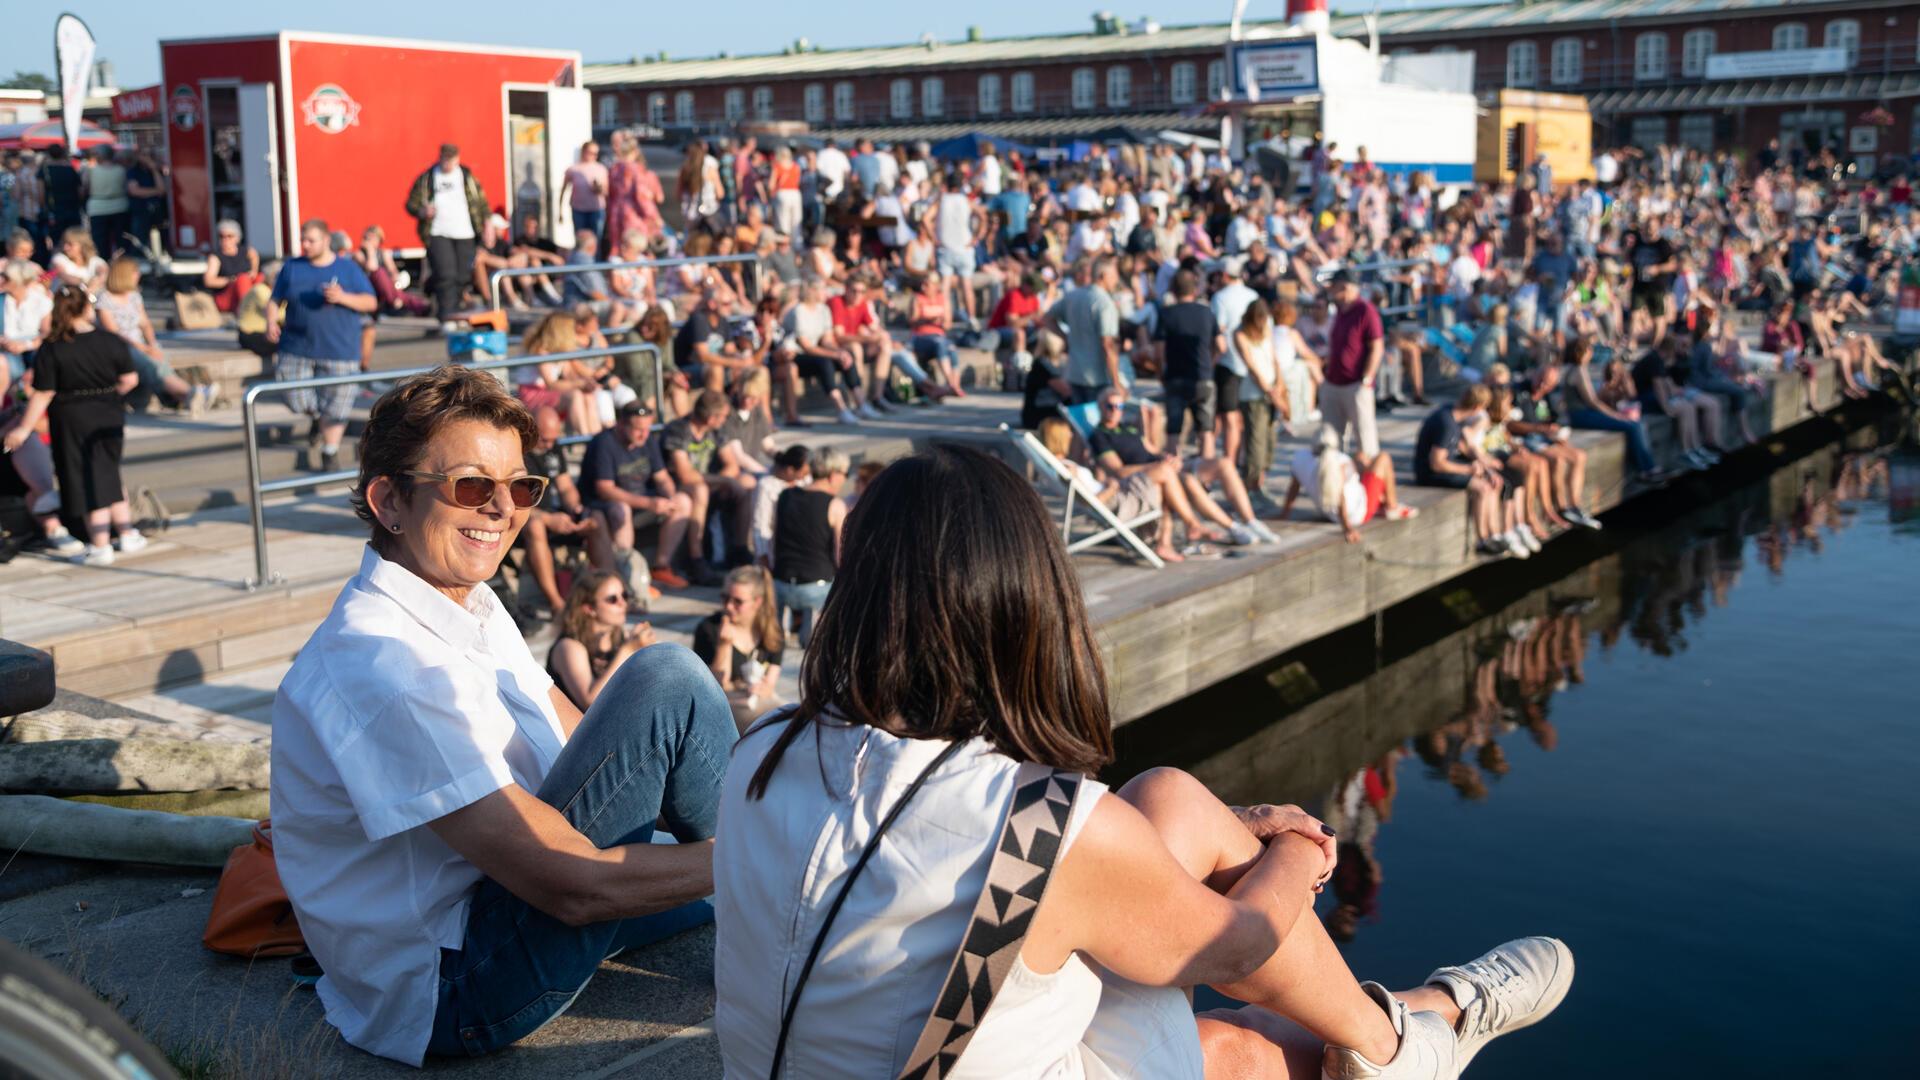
left=1110, top=407, right=1920, bottom=1080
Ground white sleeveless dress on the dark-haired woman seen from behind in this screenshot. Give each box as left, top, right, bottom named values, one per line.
left=714, top=724, right=1202, bottom=1080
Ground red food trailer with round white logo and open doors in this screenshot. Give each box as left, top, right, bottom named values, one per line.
left=159, top=31, right=591, bottom=258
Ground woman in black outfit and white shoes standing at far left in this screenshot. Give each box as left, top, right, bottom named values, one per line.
left=0, top=284, right=146, bottom=567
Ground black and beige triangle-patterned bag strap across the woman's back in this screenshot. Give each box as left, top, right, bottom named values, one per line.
left=900, top=763, right=1085, bottom=1080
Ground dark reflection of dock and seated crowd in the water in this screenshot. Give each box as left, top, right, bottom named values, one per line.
left=1114, top=418, right=1920, bottom=942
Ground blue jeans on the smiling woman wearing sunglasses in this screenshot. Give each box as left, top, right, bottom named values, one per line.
left=426, top=646, right=737, bottom=1057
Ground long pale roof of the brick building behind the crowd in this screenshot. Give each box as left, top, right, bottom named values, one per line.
left=582, top=0, right=1874, bottom=86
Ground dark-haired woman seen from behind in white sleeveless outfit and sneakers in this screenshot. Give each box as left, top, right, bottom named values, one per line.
left=714, top=446, right=1574, bottom=1080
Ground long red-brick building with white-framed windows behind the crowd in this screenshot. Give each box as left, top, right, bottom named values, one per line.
left=584, top=0, right=1920, bottom=158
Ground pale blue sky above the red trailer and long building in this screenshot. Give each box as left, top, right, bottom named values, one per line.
left=0, top=0, right=1466, bottom=86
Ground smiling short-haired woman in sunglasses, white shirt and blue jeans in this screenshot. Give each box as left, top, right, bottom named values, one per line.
left=273, top=367, right=735, bottom=1065
